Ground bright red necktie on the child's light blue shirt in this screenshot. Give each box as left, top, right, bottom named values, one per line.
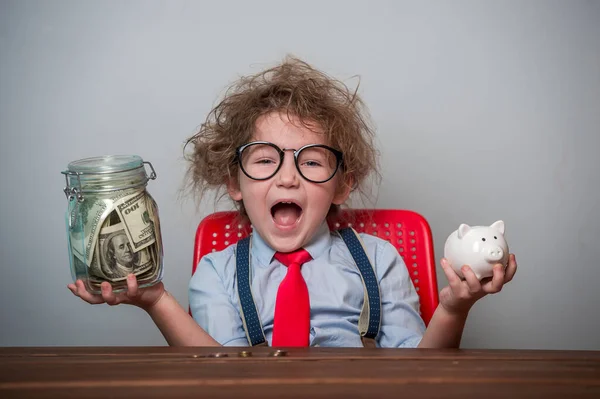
left=272, top=249, right=312, bottom=346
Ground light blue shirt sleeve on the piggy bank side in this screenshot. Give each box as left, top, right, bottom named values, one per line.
left=374, top=241, right=425, bottom=348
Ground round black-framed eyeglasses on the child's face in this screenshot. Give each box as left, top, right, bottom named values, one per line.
left=236, top=141, right=343, bottom=183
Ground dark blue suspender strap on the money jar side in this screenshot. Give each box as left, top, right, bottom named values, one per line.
left=235, top=236, right=267, bottom=346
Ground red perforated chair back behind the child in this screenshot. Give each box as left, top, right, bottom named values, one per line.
left=192, top=209, right=438, bottom=325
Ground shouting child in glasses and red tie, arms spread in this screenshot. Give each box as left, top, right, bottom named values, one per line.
left=69, top=59, right=517, bottom=348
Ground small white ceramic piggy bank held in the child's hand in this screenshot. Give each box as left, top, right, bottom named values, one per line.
left=444, top=220, right=508, bottom=280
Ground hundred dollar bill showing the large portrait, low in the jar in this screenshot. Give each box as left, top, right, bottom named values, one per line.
left=95, top=222, right=155, bottom=282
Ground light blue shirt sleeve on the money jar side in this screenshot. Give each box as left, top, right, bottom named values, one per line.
left=189, top=246, right=248, bottom=346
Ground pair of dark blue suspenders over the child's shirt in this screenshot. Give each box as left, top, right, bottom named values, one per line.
left=236, top=228, right=381, bottom=347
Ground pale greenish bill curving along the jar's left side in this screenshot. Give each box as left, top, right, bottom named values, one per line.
left=69, top=190, right=135, bottom=266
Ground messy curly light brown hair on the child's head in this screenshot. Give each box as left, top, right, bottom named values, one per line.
left=184, top=56, right=379, bottom=219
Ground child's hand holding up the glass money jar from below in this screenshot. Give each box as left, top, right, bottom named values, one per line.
left=67, top=274, right=165, bottom=311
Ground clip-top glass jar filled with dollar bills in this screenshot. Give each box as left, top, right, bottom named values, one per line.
left=61, top=155, right=163, bottom=294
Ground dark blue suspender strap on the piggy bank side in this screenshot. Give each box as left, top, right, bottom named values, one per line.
left=338, top=227, right=381, bottom=347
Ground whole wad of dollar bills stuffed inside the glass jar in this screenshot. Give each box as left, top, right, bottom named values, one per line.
left=70, top=190, right=162, bottom=293
